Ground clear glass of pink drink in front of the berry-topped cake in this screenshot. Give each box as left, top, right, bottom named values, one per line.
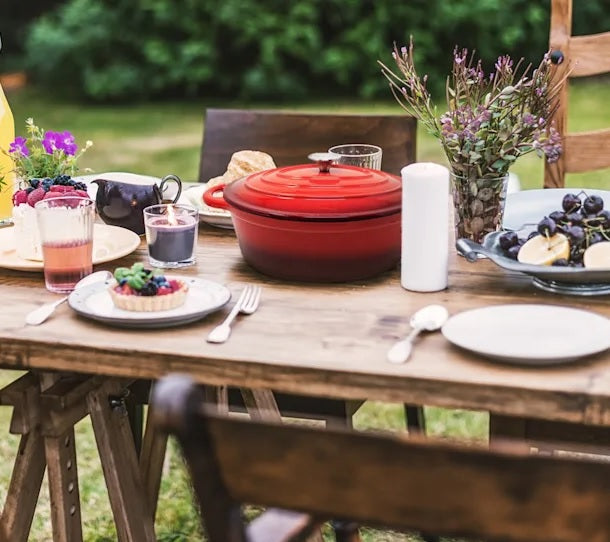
left=34, top=196, right=95, bottom=293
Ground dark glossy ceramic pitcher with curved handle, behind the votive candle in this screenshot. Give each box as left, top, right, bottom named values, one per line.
left=92, top=175, right=182, bottom=235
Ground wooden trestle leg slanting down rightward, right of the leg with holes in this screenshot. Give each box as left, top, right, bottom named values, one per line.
left=87, top=381, right=156, bottom=542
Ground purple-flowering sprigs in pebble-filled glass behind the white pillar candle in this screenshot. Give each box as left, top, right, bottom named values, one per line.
left=379, top=43, right=562, bottom=242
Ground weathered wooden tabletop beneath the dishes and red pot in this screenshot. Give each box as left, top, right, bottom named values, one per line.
left=0, top=225, right=610, bottom=426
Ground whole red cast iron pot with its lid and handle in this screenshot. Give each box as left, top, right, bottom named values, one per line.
left=203, top=153, right=402, bottom=282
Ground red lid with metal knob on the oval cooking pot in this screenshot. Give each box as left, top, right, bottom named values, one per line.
left=224, top=153, right=402, bottom=221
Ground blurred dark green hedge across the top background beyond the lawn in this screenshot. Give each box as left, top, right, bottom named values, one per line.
left=13, top=0, right=610, bottom=102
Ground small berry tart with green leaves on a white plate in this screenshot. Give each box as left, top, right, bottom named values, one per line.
left=109, top=263, right=188, bottom=312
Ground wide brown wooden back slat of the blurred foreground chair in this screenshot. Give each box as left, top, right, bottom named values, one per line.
left=208, top=419, right=610, bottom=542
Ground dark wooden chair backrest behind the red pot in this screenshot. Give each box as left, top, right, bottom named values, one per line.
left=199, top=109, right=416, bottom=182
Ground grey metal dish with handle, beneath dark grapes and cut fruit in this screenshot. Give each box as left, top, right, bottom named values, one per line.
left=455, top=230, right=610, bottom=296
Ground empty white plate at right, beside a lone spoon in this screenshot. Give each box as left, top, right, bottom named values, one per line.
left=442, top=305, right=610, bottom=365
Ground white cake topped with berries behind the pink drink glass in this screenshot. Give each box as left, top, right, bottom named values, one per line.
left=13, top=175, right=89, bottom=261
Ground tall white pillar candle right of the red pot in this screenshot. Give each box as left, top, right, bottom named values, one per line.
left=400, top=162, right=449, bottom=292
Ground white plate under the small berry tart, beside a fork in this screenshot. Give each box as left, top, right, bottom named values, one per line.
left=68, top=277, right=231, bottom=328
